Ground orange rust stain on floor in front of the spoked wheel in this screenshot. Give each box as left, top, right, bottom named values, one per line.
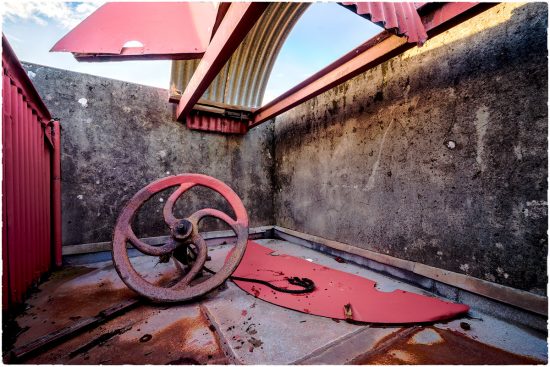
left=28, top=306, right=227, bottom=365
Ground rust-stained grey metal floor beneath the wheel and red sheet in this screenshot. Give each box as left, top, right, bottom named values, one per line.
left=3, top=239, right=547, bottom=364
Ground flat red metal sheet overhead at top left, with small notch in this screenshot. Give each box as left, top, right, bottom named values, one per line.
left=51, top=1, right=218, bottom=61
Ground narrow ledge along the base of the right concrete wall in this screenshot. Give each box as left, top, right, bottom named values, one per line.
left=273, top=226, right=548, bottom=316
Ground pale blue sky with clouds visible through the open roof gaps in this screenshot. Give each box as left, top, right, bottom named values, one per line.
left=2, top=0, right=381, bottom=103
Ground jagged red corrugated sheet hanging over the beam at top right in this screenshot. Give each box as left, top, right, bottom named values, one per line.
left=342, top=2, right=428, bottom=45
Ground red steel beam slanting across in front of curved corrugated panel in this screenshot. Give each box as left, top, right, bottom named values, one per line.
left=176, top=2, right=269, bottom=121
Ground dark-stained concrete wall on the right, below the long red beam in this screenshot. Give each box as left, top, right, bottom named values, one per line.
left=275, top=3, right=548, bottom=294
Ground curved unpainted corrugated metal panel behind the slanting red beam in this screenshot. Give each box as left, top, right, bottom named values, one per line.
left=170, top=3, right=309, bottom=108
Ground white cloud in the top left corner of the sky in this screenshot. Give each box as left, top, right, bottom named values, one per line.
left=2, top=0, right=104, bottom=29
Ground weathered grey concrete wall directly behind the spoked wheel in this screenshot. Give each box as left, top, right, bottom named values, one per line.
left=24, top=63, right=274, bottom=245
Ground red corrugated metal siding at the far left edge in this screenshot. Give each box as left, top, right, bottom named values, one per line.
left=2, top=37, right=57, bottom=309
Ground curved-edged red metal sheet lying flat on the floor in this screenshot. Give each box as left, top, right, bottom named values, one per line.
left=233, top=241, right=469, bottom=324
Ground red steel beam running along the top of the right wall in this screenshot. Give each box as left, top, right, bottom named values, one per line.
left=249, top=3, right=497, bottom=128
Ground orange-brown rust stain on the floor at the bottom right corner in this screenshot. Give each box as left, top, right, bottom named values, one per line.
left=354, top=327, right=543, bottom=365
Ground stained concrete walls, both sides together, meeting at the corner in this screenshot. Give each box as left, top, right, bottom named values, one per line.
left=20, top=3, right=548, bottom=294
